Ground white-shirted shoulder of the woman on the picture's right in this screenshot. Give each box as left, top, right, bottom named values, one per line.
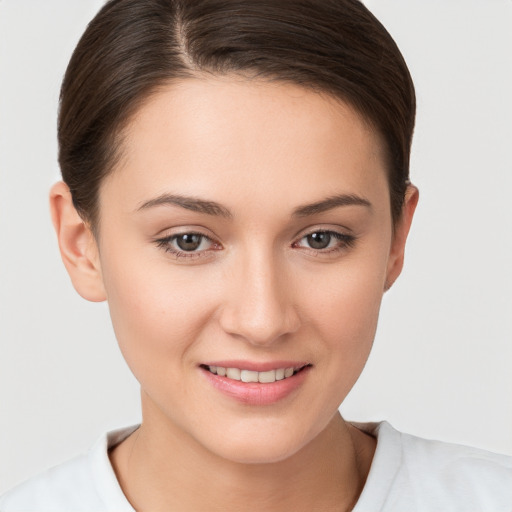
left=356, top=422, right=512, bottom=512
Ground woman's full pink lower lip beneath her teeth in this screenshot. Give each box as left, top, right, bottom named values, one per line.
left=200, top=366, right=311, bottom=405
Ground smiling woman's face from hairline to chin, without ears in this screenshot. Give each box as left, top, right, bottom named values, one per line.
left=93, top=78, right=408, bottom=462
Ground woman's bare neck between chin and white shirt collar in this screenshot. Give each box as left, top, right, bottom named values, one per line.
left=111, top=400, right=375, bottom=512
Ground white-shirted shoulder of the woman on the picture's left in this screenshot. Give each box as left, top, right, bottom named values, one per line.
left=0, top=427, right=134, bottom=512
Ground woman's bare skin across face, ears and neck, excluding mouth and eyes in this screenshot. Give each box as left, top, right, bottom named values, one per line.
left=51, top=77, right=418, bottom=511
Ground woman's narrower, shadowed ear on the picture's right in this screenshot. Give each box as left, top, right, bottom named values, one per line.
left=384, top=185, right=420, bottom=291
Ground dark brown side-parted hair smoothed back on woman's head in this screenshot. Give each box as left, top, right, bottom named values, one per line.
left=58, top=0, right=415, bottom=229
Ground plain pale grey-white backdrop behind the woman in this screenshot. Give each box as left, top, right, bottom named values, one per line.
left=0, top=0, right=512, bottom=492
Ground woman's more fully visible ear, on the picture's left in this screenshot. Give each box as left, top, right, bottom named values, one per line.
left=50, top=181, right=106, bottom=302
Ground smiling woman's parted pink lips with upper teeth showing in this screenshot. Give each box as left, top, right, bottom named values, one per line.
left=200, top=361, right=312, bottom=406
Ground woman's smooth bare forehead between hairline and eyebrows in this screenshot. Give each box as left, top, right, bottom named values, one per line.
left=100, top=77, right=387, bottom=217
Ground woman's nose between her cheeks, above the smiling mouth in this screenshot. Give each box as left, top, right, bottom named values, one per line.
left=220, top=247, right=300, bottom=346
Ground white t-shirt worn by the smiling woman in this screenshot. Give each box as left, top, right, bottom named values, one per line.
left=0, top=422, right=512, bottom=512
